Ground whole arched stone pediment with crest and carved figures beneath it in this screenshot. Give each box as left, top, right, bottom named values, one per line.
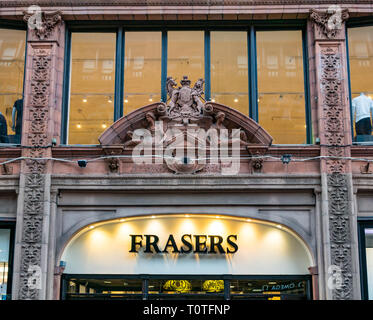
left=99, top=76, right=272, bottom=173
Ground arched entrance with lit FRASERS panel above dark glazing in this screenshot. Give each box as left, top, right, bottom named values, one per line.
left=61, top=214, right=314, bottom=299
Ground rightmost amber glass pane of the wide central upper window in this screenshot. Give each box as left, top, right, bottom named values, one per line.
left=256, top=30, right=307, bottom=144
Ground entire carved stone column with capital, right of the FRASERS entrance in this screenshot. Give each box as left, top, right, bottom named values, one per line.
left=309, top=8, right=360, bottom=300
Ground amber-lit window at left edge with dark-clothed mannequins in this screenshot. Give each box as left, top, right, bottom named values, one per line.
left=0, top=29, right=26, bottom=144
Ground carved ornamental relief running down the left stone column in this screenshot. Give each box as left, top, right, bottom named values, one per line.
left=18, top=45, right=52, bottom=300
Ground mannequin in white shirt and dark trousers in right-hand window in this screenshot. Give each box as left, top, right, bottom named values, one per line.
left=352, top=93, right=373, bottom=135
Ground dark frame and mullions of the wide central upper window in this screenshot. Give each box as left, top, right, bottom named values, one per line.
left=61, top=19, right=314, bottom=147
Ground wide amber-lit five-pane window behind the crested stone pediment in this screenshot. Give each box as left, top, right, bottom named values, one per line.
left=62, top=27, right=311, bottom=145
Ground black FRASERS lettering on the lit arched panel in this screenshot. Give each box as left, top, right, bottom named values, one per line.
left=129, top=234, right=238, bottom=254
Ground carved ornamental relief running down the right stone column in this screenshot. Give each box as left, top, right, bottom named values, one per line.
left=318, top=40, right=353, bottom=300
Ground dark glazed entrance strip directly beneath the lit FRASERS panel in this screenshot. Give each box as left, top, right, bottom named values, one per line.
left=61, top=274, right=312, bottom=300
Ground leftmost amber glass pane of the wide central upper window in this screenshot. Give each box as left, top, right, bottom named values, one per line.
left=68, top=33, right=116, bottom=144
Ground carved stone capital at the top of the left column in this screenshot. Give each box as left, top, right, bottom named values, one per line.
left=23, top=11, right=62, bottom=40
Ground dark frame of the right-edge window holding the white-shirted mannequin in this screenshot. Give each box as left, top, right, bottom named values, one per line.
left=345, top=17, right=373, bottom=146
